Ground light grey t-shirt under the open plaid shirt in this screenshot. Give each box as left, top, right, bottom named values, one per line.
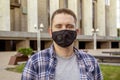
left=55, top=54, right=80, bottom=80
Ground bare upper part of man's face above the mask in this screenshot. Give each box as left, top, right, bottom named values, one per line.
left=51, top=13, right=75, bottom=32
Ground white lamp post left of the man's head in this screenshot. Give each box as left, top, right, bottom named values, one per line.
left=34, top=23, right=44, bottom=51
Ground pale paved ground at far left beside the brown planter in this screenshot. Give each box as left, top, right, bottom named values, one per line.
left=0, top=52, right=21, bottom=80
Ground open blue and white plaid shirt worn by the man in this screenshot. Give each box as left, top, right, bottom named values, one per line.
left=21, top=45, right=102, bottom=80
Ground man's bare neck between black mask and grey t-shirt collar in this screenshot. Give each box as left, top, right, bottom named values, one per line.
left=54, top=44, right=74, bottom=58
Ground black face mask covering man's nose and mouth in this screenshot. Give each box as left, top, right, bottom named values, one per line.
left=52, top=30, right=77, bottom=47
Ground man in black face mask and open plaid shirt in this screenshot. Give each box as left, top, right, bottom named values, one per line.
left=22, top=9, right=102, bottom=80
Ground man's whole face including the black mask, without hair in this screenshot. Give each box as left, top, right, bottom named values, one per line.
left=49, top=13, right=76, bottom=48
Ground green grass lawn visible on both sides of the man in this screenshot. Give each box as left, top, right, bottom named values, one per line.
left=7, top=64, right=120, bottom=80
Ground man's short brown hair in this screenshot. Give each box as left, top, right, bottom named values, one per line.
left=51, top=8, right=77, bottom=26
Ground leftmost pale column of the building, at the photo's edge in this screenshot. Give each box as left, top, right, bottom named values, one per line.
left=0, top=0, right=10, bottom=31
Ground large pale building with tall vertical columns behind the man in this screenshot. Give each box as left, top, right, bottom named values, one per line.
left=0, top=0, right=120, bottom=51
